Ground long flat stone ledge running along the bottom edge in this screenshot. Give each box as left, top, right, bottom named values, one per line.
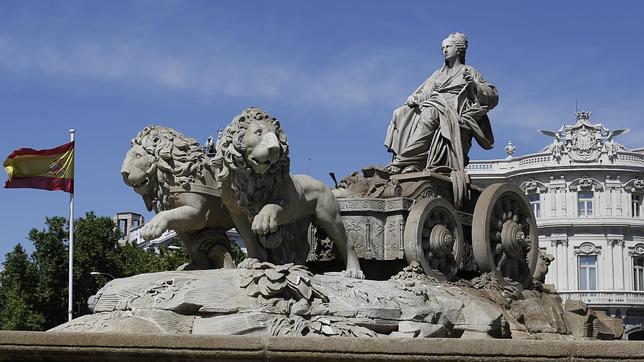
left=0, top=331, right=644, bottom=362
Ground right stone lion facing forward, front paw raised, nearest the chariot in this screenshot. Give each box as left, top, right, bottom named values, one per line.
left=213, top=108, right=364, bottom=278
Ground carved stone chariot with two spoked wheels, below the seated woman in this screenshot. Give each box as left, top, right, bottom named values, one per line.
left=309, top=167, right=539, bottom=287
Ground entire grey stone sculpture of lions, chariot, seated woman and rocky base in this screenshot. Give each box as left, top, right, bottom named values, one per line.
left=54, top=33, right=623, bottom=340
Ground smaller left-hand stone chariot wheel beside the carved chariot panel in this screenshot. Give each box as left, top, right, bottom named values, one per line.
left=404, top=197, right=463, bottom=280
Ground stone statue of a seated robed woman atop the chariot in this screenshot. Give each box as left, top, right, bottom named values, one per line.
left=385, top=33, right=499, bottom=174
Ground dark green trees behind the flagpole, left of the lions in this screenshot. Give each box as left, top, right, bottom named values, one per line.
left=0, top=212, right=196, bottom=330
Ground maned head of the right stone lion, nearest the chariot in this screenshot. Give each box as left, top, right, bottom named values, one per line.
left=213, top=108, right=290, bottom=217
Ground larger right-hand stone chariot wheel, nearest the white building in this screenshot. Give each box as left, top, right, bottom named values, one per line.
left=472, top=183, right=539, bottom=287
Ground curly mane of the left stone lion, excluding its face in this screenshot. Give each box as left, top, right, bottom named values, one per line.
left=132, top=125, right=210, bottom=213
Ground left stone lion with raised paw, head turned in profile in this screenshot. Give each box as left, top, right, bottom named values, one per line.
left=121, top=126, right=233, bottom=269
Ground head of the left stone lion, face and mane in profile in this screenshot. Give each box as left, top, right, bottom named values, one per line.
left=121, top=126, right=209, bottom=212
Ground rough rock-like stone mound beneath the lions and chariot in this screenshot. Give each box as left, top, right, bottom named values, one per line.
left=52, top=262, right=618, bottom=339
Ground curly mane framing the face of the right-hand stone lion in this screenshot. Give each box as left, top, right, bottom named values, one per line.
left=213, top=107, right=290, bottom=219
